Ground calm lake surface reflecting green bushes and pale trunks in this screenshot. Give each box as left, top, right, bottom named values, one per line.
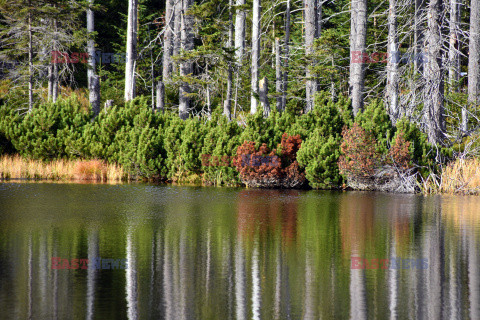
left=0, top=183, right=480, bottom=320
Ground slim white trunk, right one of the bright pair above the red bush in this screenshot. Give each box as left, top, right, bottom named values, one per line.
left=250, top=0, right=262, bottom=114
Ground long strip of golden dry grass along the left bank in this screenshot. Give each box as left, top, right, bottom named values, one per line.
left=0, top=155, right=128, bottom=182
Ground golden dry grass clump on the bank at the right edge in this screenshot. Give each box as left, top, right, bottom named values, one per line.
left=422, top=158, right=480, bottom=194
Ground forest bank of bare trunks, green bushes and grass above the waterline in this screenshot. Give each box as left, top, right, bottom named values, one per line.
left=0, top=0, right=480, bottom=193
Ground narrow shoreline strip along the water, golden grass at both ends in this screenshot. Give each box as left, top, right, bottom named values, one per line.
left=0, top=155, right=480, bottom=196
